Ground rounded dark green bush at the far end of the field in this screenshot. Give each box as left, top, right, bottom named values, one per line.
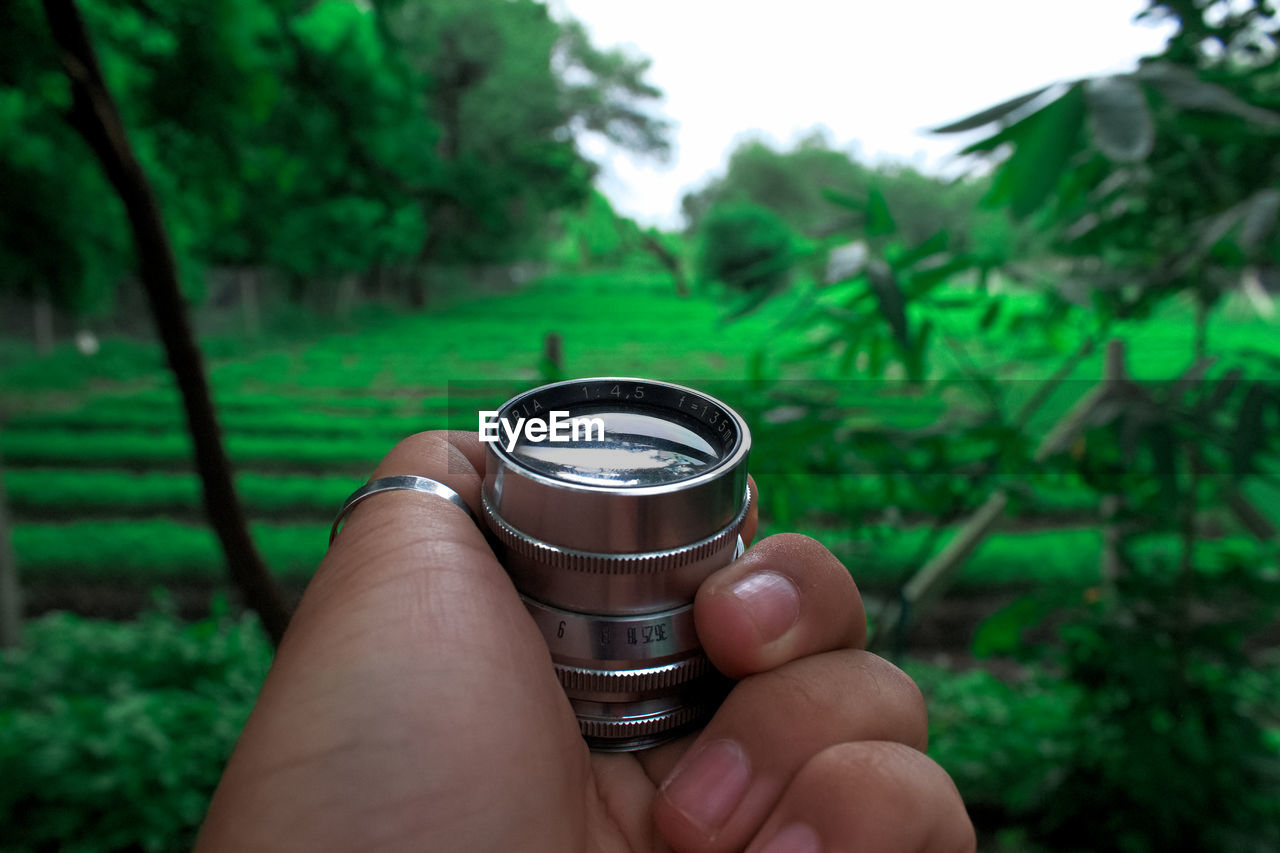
left=698, top=204, right=796, bottom=292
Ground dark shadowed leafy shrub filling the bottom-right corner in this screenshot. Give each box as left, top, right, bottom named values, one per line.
left=967, top=540, right=1280, bottom=852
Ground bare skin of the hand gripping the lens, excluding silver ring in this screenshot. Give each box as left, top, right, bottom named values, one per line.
left=196, top=432, right=975, bottom=853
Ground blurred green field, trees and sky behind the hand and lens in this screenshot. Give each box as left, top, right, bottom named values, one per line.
left=0, top=0, right=1280, bottom=853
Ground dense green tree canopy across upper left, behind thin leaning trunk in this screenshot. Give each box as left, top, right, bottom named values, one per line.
left=0, top=0, right=669, bottom=322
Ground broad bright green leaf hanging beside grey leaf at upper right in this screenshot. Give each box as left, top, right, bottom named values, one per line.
left=987, top=85, right=1084, bottom=219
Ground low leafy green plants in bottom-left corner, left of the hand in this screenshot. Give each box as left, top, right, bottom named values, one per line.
left=0, top=603, right=270, bottom=852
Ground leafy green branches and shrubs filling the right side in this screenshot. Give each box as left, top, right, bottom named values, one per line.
left=716, top=4, right=1280, bottom=852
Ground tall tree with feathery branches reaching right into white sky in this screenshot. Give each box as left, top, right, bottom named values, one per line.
left=378, top=0, right=669, bottom=285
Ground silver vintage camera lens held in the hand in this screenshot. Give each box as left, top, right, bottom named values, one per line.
left=484, top=378, right=751, bottom=751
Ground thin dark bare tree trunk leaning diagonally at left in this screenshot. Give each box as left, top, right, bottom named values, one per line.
left=44, top=0, right=289, bottom=643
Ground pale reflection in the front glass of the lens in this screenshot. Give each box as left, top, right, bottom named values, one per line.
left=512, top=407, right=721, bottom=487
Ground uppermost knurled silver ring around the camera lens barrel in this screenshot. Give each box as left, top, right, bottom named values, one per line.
left=484, top=489, right=751, bottom=575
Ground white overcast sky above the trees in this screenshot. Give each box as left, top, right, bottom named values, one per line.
left=548, top=0, right=1171, bottom=228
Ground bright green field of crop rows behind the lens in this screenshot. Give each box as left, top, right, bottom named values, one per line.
left=0, top=273, right=1280, bottom=625
